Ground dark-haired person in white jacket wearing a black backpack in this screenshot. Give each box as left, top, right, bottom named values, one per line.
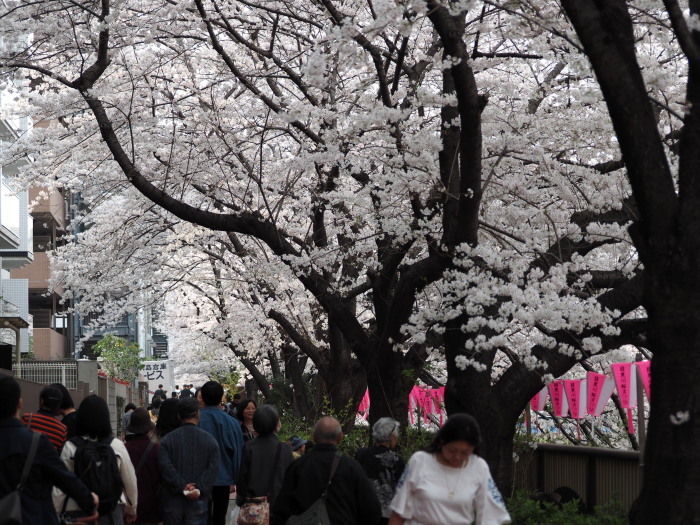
left=54, top=395, right=138, bottom=525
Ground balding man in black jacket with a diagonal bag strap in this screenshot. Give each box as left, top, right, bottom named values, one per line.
left=270, top=417, right=382, bottom=525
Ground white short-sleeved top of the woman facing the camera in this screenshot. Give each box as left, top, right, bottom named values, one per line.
left=391, top=452, right=510, bottom=525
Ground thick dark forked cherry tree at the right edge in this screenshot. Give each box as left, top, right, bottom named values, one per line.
left=562, top=0, right=700, bottom=523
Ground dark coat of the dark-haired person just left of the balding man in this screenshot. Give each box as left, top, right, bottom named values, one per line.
left=236, top=434, right=292, bottom=506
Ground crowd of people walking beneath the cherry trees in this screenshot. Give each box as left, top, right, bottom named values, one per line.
left=0, top=375, right=509, bottom=525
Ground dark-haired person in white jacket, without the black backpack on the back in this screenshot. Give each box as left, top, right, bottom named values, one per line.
left=53, top=395, right=138, bottom=525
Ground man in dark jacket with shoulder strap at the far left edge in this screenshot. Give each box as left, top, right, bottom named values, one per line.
left=0, top=374, right=97, bottom=525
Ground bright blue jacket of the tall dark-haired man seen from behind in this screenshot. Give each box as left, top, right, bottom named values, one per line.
left=199, top=407, right=243, bottom=487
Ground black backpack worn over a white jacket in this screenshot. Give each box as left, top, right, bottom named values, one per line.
left=70, top=436, right=124, bottom=516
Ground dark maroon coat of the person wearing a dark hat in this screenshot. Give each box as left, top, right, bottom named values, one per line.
left=124, top=434, right=163, bottom=523
